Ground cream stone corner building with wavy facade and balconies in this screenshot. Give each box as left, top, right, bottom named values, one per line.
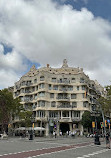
left=14, top=59, right=104, bottom=135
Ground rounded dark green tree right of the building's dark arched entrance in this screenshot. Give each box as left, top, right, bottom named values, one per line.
left=81, top=111, right=92, bottom=128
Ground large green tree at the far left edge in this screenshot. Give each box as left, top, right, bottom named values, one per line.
left=0, top=89, right=22, bottom=131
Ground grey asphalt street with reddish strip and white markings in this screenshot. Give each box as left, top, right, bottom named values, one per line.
left=0, top=137, right=111, bottom=158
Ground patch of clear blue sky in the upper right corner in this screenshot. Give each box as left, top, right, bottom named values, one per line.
left=54, top=0, right=111, bottom=21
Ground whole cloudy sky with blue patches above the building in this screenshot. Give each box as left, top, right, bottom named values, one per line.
left=0, top=0, right=111, bottom=89
